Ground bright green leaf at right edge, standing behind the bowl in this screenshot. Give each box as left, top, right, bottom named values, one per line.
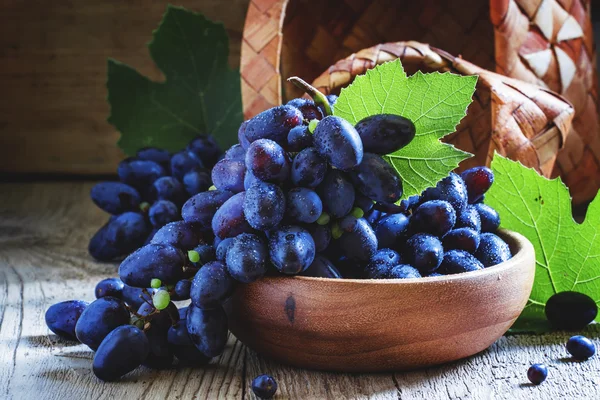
left=485, top=154, right=600, bottom=332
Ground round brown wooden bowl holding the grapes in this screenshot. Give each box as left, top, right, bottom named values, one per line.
left=226, top=231, right=535, bottom=372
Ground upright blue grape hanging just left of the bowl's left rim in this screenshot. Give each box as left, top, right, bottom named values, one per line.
left=190, top=261, right=234, bottom=308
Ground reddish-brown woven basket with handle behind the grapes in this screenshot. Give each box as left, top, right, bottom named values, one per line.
left=241, top=0, right=600, bottom=202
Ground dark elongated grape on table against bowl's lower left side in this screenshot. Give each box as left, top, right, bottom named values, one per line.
left=186, top=305, right=228, bottom=358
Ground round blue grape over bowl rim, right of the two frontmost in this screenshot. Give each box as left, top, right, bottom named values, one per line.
left=269, top=226, right=315, bottom=275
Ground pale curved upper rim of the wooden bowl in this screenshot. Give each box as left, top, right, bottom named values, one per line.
left=261, top=229, right=535, bottom=285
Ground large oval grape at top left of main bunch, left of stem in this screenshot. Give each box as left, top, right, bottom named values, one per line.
left=244, top=106, right=304, bottom=144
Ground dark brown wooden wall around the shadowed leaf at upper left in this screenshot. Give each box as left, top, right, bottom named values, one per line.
left=0, top=0, right=248, bottom=174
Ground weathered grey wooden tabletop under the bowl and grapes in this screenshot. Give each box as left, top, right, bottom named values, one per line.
left=0, top=182, right=600, bottom=400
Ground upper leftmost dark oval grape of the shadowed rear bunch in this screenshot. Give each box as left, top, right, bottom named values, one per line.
left=90, top=182, right=141, bottom=215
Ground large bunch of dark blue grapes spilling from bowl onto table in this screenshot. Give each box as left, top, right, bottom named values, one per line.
left=46, top=85, right=511, bottom=386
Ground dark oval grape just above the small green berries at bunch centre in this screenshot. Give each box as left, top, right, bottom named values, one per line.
left=317, top=169, right=355, bottom=218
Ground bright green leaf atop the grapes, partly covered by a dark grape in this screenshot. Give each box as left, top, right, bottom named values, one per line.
left=334, top=60, right=477, bottom=198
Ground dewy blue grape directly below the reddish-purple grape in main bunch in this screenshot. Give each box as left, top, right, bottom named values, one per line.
left=243, top=182, right=286, bottom=231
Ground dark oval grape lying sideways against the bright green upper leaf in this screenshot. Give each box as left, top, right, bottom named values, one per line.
left=354, top=114, right=416, bottom=154
